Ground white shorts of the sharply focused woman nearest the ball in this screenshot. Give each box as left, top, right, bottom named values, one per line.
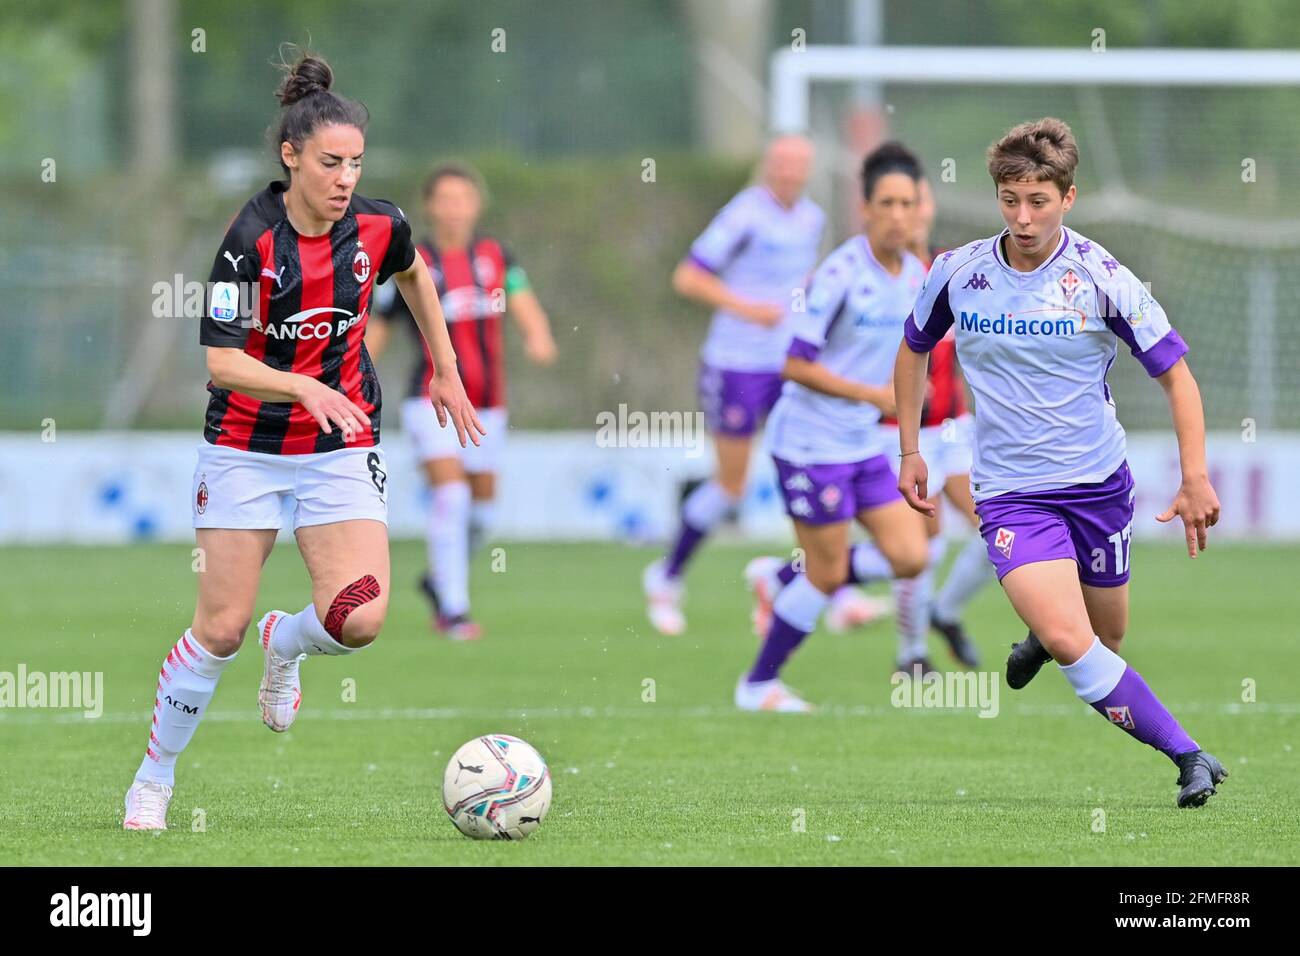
left=190, top=442, right=389, bottom=531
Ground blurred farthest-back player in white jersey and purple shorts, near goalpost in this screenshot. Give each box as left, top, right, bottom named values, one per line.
left=642, top=137, right=826, bottom=635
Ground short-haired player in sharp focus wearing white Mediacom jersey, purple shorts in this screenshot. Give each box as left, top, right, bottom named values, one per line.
left=894, top=118, right=1227, bottom=806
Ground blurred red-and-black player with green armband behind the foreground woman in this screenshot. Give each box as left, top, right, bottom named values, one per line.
left=365, top=164, right=555, bottom=640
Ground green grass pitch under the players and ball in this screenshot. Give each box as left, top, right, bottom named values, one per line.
left=0, top=541, right=1300, bottom=866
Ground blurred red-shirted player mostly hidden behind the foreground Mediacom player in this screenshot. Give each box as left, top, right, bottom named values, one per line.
left=881, top=179, right=995, bottom=671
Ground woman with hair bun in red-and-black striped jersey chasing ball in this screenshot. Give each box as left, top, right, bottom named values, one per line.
left=124, top=53, right=482, bottom=830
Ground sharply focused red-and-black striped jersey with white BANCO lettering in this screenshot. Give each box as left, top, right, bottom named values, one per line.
left=199, top=182, right=415, bottom=455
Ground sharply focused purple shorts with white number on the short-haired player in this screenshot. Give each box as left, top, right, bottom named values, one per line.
left=975, top=462, right=1134, bottom=588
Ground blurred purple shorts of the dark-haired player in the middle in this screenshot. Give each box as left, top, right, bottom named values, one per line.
left=772, top=455, right=902, bottom=524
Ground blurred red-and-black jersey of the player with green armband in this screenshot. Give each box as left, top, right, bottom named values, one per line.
left=376, top=235, right=516, bottom=408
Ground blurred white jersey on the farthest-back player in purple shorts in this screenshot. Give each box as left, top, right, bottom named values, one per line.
left=689, top=186, right=826, bottom=372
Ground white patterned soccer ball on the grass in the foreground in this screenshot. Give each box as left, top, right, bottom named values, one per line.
left=442, top=734, right=551, bottom=840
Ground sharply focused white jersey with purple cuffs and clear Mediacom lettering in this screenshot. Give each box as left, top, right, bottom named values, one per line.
left=907, top=228, right=1187, bottom=501
